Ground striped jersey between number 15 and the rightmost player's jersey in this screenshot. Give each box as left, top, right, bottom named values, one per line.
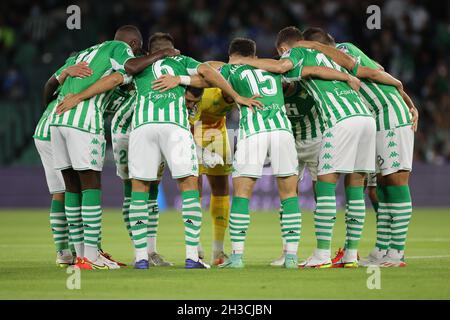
left=281, top=48, right=372, bottom=128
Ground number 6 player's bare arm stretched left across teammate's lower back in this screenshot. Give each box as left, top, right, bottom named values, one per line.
left=56, top=72, right=124, bottom=114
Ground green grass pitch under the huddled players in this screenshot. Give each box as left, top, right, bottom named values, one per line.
left=0, top=209, right=450, bottom=299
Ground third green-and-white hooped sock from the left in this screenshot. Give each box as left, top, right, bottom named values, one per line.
left=81, top=189, right=102, bottom=261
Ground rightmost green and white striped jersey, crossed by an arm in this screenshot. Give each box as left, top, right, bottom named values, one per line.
left=337, top=43, right=411, bottom=131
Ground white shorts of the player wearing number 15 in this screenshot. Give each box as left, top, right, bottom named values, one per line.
left=233, top=130, right=298, bottom=178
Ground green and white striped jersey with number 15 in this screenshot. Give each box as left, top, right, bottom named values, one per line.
left=220, top=64, right=292, bottom=139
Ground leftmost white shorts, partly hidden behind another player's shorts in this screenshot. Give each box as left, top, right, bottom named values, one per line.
left=34, top=139, right=66, bottom=194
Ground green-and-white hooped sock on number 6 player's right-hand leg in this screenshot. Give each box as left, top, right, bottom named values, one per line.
left=181, top=190, right=202, bottom=261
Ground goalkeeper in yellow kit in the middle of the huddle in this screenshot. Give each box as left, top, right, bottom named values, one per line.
left=186, top=87, right=234, bottom=265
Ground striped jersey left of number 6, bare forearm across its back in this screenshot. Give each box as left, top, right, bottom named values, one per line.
left=51, top=41, right=134, bottom=134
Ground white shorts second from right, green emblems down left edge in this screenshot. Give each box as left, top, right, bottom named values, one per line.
left=318, top=116, right=376, bottom=176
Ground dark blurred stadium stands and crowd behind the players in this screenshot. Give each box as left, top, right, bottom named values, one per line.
left=0, top=0, right=450, bottom=209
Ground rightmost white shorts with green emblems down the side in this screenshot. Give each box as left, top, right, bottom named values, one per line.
left=376, top=126, right=414, bottom=176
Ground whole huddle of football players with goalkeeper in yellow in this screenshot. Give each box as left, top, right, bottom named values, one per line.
left=34, top=25, right=418, bottom=270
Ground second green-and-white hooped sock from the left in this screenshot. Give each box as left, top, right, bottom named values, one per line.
left=64, top=192, right=84, bottom=258
